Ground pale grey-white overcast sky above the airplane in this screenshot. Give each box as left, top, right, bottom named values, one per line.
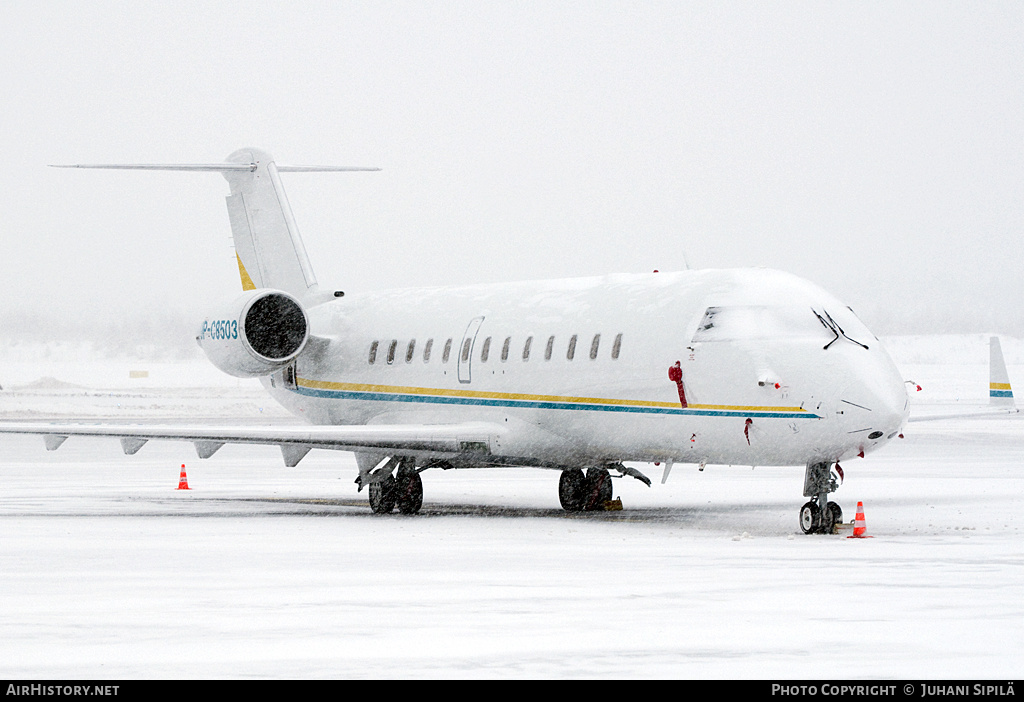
left=0, top=0, right=1024, bottom=336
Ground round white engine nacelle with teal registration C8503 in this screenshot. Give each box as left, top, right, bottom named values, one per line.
left=196, top=288, right=309, bottom=378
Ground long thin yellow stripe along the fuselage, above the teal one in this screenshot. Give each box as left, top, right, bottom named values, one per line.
left=296, top=378, right=807, bottom=412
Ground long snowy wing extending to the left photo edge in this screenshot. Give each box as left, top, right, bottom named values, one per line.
left=0, top=422, right=505, bottom=467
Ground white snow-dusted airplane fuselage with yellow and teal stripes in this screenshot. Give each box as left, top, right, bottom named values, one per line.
left=264, top=269, right=907, bottom=467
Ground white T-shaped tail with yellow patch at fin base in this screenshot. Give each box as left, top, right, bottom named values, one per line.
left=51, top=148, right=380, bottom=299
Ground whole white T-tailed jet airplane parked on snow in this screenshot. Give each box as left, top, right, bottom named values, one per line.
left=0, top=148, right=1009, bottom=534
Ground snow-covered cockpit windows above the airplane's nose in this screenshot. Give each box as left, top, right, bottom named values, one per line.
left=693, top=305, right=834, bottom=344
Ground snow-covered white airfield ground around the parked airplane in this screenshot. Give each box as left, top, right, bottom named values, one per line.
left=0, top=335, right=1024, bottom=681
